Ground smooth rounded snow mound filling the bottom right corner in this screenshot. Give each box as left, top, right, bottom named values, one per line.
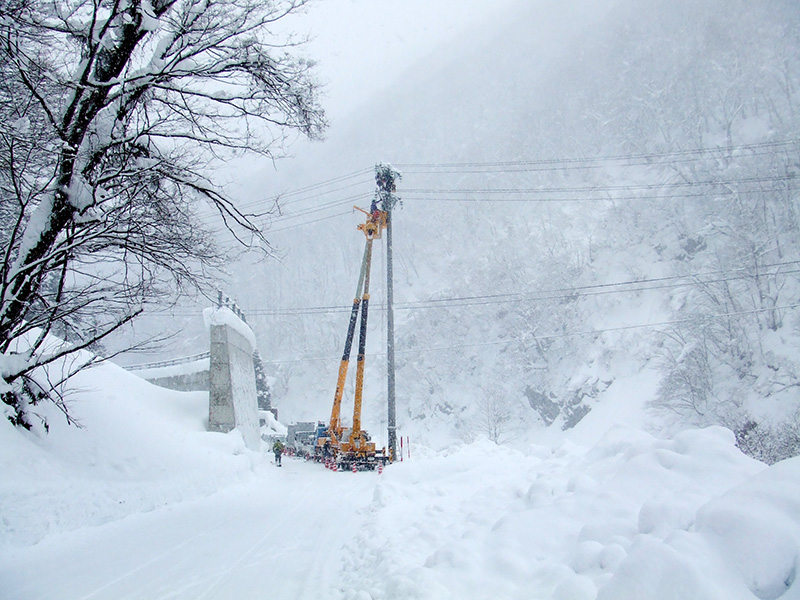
left=598, top=458, right=800, bottom=600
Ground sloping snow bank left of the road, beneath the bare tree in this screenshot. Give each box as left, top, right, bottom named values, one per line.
left=0, top=363, right=268, bottom=545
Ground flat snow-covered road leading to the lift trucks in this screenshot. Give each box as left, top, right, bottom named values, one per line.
left=0, top=459, right=378, bottom=600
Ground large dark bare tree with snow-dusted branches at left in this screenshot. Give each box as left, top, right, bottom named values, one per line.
left=0, top=0, right=325, bottom=427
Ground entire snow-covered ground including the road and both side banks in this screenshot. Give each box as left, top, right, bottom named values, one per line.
left=0, top=365, right=800, bottom=600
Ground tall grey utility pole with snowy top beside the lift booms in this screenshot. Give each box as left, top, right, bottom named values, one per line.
left=375, top=163, right=401, bottom=461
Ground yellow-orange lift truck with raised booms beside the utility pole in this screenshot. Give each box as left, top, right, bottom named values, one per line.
left=314, top=202, right=389, bottom=469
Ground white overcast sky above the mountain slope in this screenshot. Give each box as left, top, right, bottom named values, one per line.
left=290, top=0, right=519, bottom=121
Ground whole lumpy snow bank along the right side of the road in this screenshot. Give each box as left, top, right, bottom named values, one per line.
left=348, top=428, right=800, bottom=600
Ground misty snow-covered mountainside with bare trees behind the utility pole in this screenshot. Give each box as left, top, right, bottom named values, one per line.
left=126, top=0, right=800, bottom=453
